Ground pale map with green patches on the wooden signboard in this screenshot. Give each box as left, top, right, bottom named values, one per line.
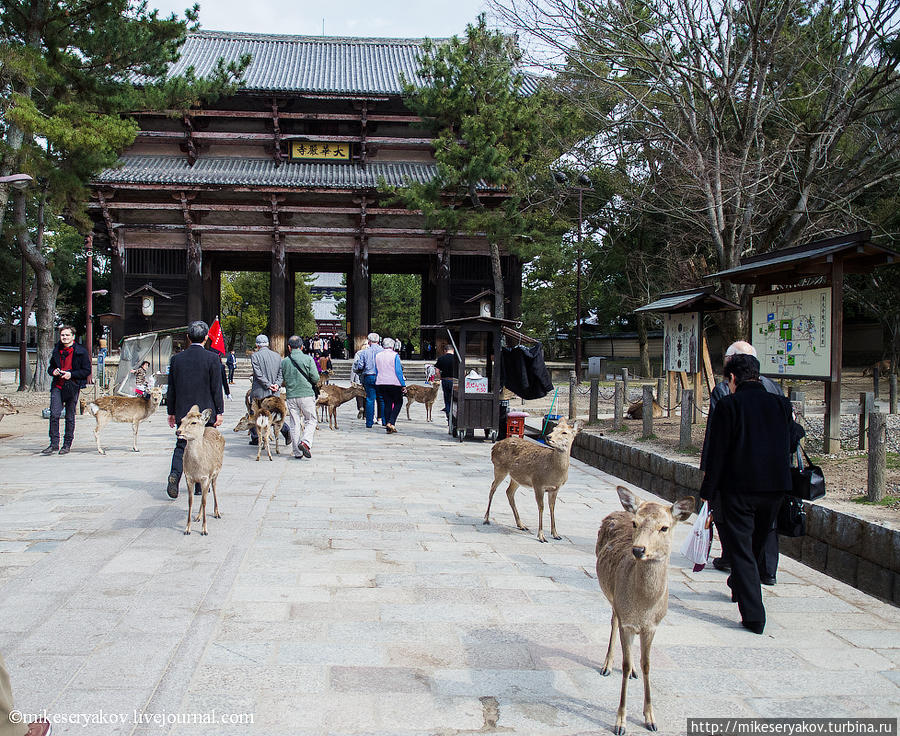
left=751, top=287, right=831, bottom=378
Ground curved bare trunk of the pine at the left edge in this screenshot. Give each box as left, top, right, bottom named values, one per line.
left=13, top=191, right=59, bottom=391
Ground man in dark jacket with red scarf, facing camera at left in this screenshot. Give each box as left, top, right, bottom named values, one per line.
left=41, top=325, right=91, bottom=455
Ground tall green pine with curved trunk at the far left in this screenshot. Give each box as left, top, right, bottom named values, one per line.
left=0, top=0, right=249, bottom=390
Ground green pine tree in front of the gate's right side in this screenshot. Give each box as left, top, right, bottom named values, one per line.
left=390, top=15, right=561, bottom=317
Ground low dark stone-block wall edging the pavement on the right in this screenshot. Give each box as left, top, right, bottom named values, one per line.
left=572, top=432, right=900, bottom=605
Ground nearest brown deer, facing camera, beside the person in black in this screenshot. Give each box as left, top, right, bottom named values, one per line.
left=596, top=486, right=694, bottom=734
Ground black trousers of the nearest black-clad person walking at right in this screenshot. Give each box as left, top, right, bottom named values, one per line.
left=719, top=491, right=783, bottom=623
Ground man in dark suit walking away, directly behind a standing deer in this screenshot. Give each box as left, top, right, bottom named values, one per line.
left=166, top=321, right=225, bottom=498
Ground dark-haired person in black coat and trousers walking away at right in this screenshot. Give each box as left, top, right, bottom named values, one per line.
left=700, top=355, right=793, bottom=634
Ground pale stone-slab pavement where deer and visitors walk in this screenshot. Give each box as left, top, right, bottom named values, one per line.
left=0, top=385, right=900, bottom=736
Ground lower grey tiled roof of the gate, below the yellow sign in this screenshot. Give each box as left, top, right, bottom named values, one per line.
left=95, top=156, right=437, bottom=189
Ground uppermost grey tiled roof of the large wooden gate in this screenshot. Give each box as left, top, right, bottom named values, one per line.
left=163, top=31, right=537, bottom=95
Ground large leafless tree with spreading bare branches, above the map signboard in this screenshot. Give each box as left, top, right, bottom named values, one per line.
left=495, top=0, right=900, bottom=339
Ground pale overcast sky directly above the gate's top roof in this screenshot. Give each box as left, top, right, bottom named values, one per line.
left=148, top=0, right=496, bottom=38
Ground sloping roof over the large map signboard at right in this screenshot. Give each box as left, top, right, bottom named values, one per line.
left=703, top=230, right=900, bottom=284
